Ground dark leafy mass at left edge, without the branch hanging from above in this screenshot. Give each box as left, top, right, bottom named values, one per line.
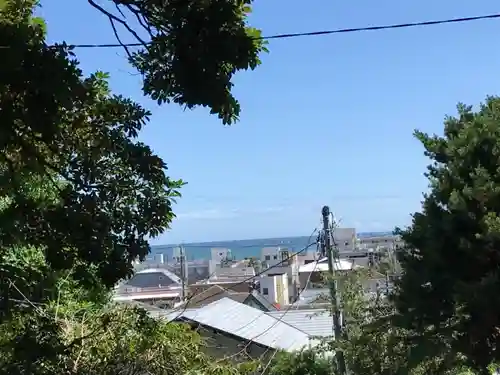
left=0, top=1, right=183, bottom=286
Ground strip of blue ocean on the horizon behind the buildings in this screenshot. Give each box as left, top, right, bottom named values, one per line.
left=148, top=232, right=391, bottom=262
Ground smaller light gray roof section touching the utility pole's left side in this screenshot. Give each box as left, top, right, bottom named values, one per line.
left=267, top=307, right=333, bottom=337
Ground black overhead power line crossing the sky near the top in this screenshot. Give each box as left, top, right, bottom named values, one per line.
left=45, top=13, right=500, bottom=48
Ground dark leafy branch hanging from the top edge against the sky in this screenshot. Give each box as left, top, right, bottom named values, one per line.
left=89, top=0, right=267, bottom=124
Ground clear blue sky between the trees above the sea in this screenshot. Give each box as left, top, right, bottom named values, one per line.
left=40, top=0, right=500, bottom=244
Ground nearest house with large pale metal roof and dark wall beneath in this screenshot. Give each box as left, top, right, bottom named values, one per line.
left=163, top=297, right=319, bottom=360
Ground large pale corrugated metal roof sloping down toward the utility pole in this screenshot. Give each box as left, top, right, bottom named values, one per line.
left=165, top=297, right=311, bottom=351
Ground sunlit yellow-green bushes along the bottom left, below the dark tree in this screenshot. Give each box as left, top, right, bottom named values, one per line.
left=0, top=301, right=249, bottom=375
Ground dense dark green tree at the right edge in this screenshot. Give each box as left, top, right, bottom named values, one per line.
left=394, top=97, right=500, bottom=374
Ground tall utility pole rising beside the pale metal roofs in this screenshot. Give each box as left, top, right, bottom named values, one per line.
left=321, top=206, right=346, bottom=375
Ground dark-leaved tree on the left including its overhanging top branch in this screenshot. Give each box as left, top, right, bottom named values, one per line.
left=0, top=0, right=270, bottom=286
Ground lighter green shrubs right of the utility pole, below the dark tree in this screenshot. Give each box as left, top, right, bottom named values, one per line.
left=329, top=269, right=472, bottom=375
